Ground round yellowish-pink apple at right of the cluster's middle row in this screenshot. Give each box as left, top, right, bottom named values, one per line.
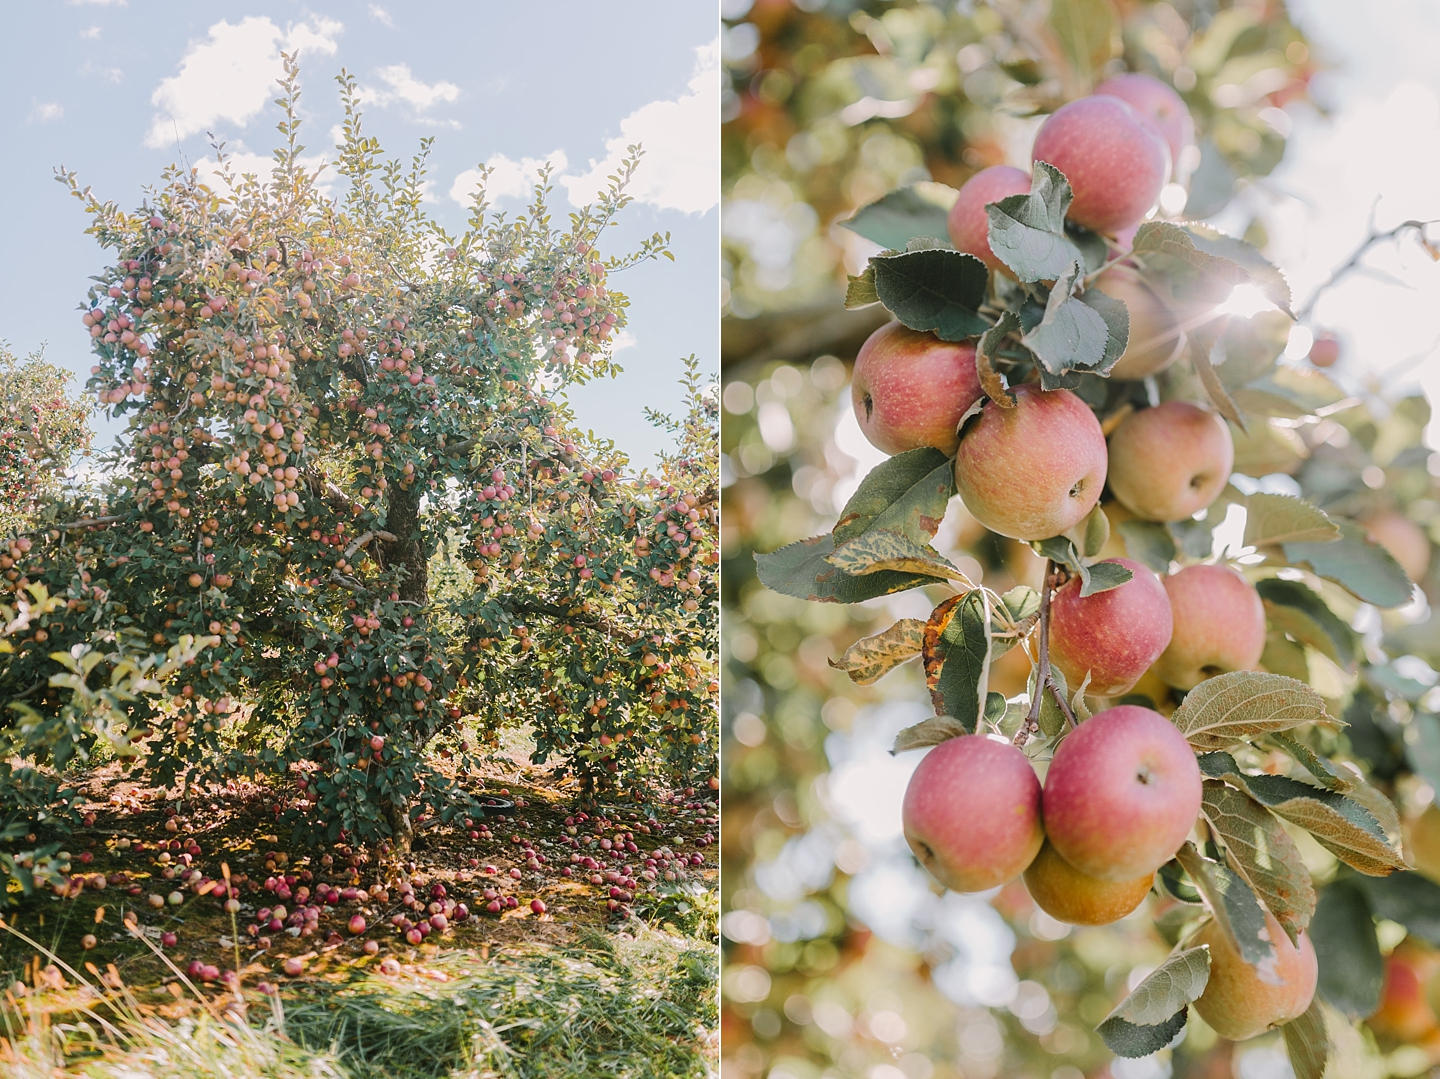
left=1109, top=400, right=1236, bottom=521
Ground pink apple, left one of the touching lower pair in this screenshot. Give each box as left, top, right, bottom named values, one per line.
left=901, top=735, right=1045, bottom=892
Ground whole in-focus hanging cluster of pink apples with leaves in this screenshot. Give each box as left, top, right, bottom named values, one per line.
left=757, top=75, right=1428, bottom=1076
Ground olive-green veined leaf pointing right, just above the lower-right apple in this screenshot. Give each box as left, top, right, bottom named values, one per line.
left=1171, top=671, right=1331, bottom=749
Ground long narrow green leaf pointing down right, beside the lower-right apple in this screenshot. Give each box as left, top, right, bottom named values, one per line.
left=1197, top=753, right=1405, bottom=876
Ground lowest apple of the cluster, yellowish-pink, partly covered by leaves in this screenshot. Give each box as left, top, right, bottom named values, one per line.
left=1191, top=910, right=1319, bottom=1042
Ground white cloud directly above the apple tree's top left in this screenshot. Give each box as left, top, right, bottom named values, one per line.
left=145, top=16, right=343, bottom=147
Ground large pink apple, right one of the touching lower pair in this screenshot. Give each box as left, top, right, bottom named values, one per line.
left=1043, top=704, right=1201, bottom=880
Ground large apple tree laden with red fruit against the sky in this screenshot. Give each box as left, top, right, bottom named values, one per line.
left=0, top=61, right=717, bottom=849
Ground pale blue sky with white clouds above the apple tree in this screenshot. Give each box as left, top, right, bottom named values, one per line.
left=0, top=0, right=720, bottom=462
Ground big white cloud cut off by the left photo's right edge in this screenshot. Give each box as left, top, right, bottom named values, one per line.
left=560, top=37, right=720, bottom=213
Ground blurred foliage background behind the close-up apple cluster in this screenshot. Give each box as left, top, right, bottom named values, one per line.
left=721, top=0, right=1440, bottom=1079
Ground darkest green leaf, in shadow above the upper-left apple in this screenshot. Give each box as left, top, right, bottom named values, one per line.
left=870, top=248, right=991, bottom=341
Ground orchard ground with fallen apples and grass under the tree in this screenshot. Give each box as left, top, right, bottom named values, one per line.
left=0, top=752, right=719, bottom=1079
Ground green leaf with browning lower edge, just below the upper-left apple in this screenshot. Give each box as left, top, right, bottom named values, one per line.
left=834, top=448, right=955, bottom=546
